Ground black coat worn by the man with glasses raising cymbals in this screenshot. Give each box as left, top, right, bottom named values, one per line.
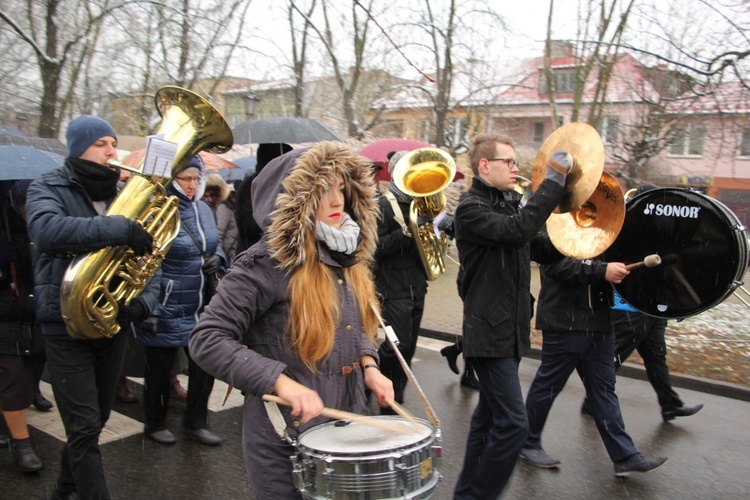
left=454, top=177, right=565, bottom=358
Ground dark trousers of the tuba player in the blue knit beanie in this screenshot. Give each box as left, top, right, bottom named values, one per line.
left=45, top=334, right=127, bottom=500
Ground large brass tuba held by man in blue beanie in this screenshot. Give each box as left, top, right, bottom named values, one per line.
left=60, top=86, right=234, bottom=339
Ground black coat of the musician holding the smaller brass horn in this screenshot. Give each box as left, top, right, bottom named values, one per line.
left=375, top=196, right=427, bottom=300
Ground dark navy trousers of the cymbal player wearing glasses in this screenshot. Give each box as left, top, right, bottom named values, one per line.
left=453, top=358, right=528, bottom=500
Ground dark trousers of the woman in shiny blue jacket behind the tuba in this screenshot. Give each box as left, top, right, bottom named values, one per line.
left=143, top=347, right=214, bottom=432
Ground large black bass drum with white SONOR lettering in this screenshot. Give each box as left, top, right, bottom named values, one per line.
left=606, top=188, right=748, bottom=319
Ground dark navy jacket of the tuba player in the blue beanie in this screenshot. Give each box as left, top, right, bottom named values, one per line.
left=26, top=160, right=159, bottom=335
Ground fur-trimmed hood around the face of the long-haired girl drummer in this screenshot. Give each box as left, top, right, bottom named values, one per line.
left=251, top=142, right=378, bottom=271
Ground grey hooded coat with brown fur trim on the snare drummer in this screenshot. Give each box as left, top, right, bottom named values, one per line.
left=190, top=142, right=377, bottom=499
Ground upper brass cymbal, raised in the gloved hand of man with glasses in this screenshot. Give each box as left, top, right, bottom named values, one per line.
left=531, top=122, right=604, bottom=214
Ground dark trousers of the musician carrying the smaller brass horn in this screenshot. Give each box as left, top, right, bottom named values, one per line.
left=378, top=295, right=424, bottom=403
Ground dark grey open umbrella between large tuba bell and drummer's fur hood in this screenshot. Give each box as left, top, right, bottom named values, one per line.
left=232, top=116, right=343, bottom=144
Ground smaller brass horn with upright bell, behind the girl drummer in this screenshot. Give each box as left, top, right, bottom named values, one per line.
left=391, top=148, right=456, bottom=281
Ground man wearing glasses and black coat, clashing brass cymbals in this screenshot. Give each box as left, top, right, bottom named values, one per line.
left=454, top=134, right=573, bottom=499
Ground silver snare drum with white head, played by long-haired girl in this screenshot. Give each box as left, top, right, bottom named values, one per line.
left=292, top=416, right=441, bottom=500
